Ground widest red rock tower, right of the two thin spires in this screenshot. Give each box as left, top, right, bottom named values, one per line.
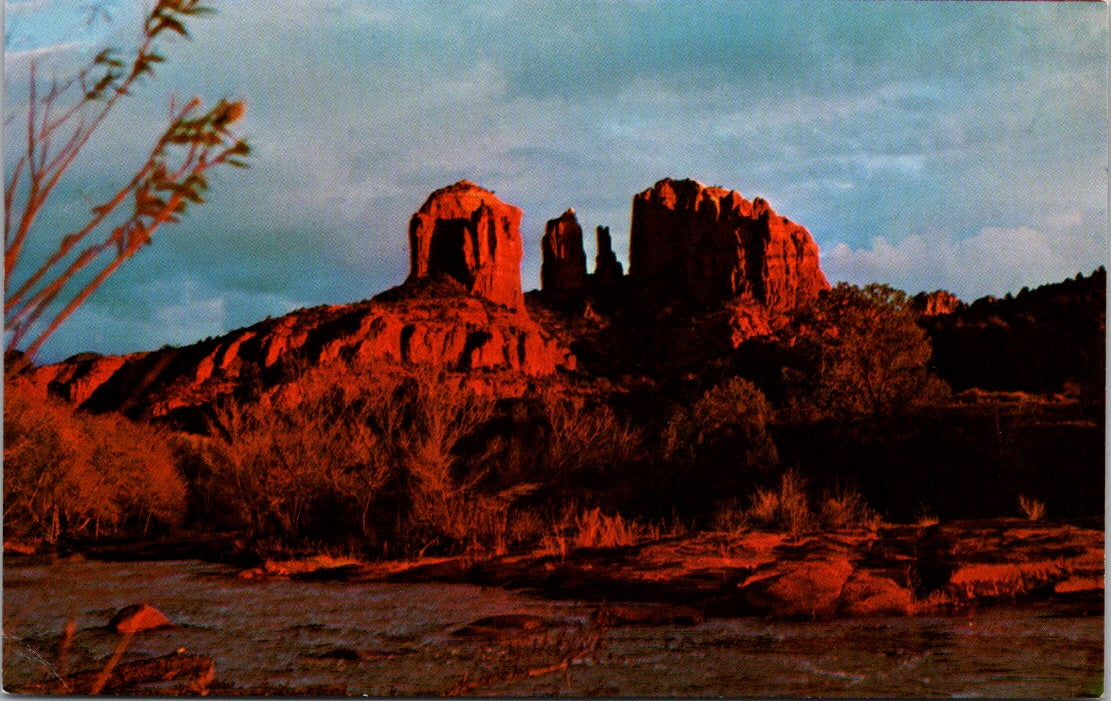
left=629, top=179, right=829, bottom=313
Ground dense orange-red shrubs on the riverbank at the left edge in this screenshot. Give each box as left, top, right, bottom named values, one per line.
left=3, top=383, right=186, bottom=542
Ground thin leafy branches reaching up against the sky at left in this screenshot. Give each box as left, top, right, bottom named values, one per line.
left=3, top=0, right=250, bottom=371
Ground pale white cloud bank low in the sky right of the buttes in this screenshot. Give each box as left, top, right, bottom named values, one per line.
left=822, top=227, right=1107, bottom=300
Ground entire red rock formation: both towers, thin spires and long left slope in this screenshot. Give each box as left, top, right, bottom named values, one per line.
left=17, top=179, right=829, bottom=418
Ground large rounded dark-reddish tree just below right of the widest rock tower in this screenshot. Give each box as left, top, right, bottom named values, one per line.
left=789, top=282, right=948, bottom=415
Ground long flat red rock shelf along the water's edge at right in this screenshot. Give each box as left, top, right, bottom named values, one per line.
left=258, top=519, right=1103, bottom=623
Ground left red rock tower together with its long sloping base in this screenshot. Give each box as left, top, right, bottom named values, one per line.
left=16, top=181, right=575, bottom=420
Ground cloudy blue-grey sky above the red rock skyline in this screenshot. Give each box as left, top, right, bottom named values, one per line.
left=4, top=0, right=1109, bottom=361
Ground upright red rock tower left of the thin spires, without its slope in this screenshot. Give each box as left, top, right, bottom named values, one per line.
left=409, top=180, right=524, bottom=309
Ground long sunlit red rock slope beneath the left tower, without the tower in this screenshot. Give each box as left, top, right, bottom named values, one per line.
left=14, top=293, right=575, bottom=418
